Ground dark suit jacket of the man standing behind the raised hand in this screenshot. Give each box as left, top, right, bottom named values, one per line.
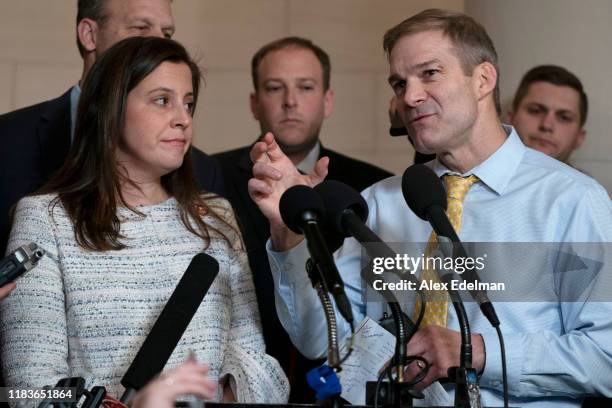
left=214, top=146, right=392, bottom=402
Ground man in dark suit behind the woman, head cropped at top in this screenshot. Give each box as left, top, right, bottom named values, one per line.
left=0, top=0, right=223, bottom=254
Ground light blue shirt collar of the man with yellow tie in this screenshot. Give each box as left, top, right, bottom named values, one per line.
left=431, top=125, right=526, bottom=195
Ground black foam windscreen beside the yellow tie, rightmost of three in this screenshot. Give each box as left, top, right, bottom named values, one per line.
left=402, top=164, right=446, bottom=220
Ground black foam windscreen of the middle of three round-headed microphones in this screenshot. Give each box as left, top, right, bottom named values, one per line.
left=314, top=180, right=368, bottom=237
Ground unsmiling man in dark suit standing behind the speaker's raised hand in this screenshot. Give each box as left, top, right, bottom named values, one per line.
left=215, top=37, right=391, bottom=402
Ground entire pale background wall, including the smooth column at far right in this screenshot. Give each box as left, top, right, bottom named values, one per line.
left=0, top=0, right=612, bottom=191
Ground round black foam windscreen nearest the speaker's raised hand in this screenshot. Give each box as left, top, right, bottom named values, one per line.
left=279, top=185, right=325, bottom=234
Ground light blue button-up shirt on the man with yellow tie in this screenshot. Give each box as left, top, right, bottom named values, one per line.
left=268, top=126, right=612, bottom=407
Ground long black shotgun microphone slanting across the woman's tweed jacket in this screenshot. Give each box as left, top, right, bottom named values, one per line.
left=121, top=253, right=219, bottom=404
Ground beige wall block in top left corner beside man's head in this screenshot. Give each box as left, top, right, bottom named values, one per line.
left=0, top=0, right=79, bottom=63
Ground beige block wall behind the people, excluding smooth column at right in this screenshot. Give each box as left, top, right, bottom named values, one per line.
left=0, top=0, right=464, bottom=177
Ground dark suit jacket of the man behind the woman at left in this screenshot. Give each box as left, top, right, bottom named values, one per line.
left=0, top=90, right=224, bottom=255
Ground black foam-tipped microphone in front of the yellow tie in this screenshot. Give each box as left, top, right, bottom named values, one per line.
left=402, top=164, right=500, bottom=327
